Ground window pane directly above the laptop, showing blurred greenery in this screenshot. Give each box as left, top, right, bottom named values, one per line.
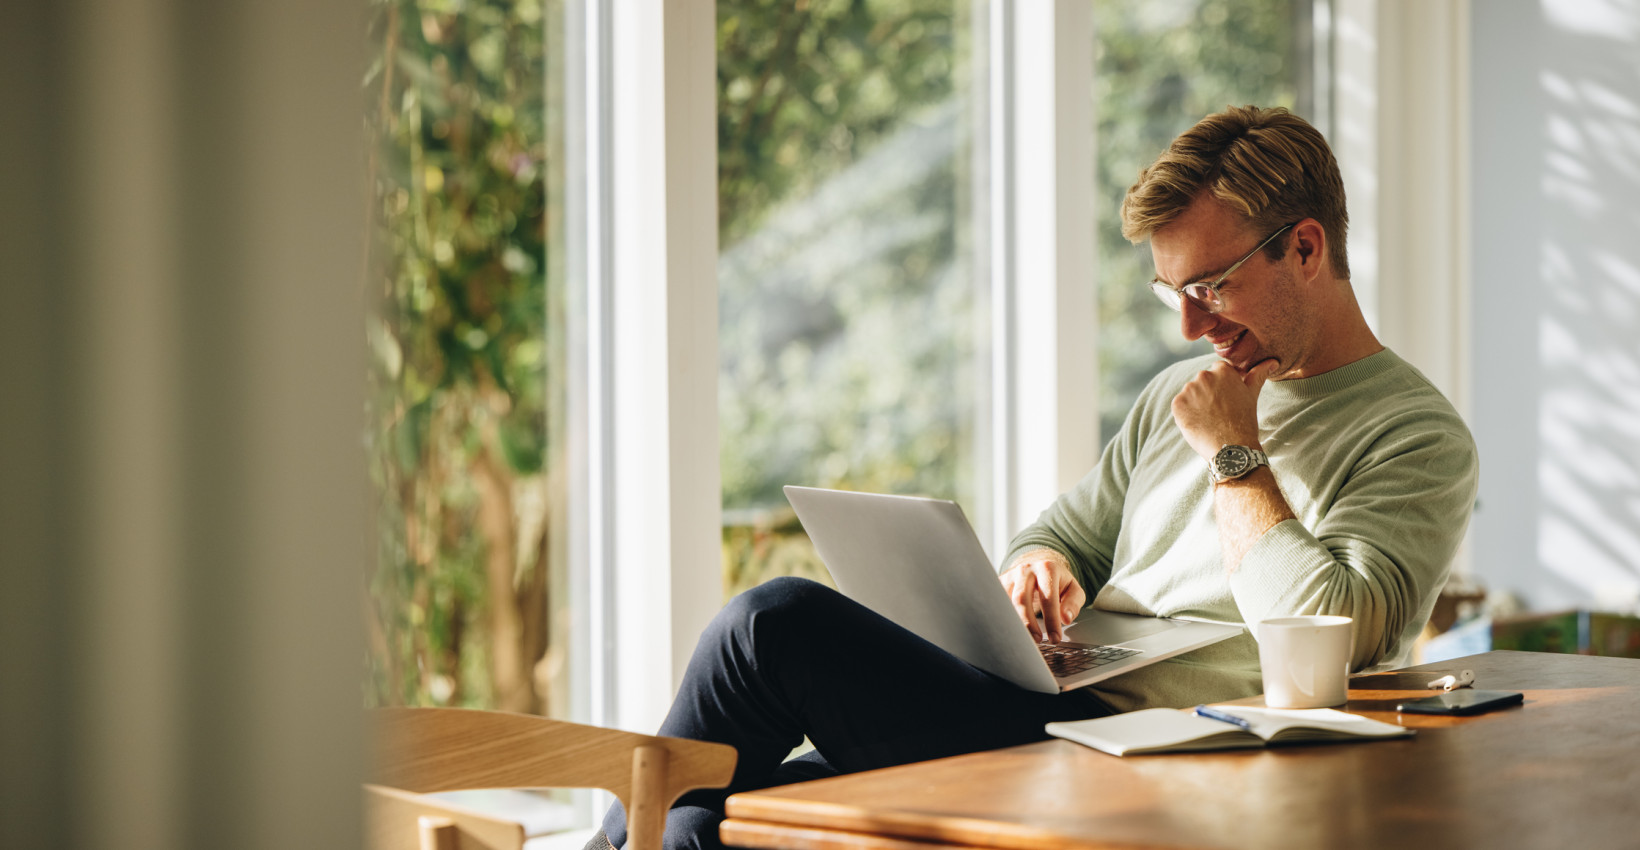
left=717, top=0, right=989, bottom=594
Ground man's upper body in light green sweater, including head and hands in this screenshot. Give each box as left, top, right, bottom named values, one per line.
left=1002, top=108, right=1478, bottom=711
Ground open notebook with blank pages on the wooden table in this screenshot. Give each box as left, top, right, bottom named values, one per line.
left=1046, top=706, right=1412, bottom=755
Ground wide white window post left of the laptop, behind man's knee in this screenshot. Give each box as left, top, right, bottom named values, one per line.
left=607, top=0, right=723, bottom=730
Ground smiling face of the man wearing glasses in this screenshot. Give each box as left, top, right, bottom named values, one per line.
left=1150, top=195, right=1315, bottom=381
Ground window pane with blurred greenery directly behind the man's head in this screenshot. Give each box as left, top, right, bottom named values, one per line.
left=1094, top=0, right=1328, bottom=440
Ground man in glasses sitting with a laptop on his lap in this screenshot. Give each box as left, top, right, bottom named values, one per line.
left=592, top=107, right=1478, bottom=848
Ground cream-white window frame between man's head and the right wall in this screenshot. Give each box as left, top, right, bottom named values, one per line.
left=1332, top=0, right=1469, bottom=412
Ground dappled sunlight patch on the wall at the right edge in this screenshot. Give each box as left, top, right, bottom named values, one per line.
left=1535, top=0, right=1640, bottom=607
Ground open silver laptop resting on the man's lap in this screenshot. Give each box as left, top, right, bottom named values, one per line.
left=786, top=487, right=1243, bottom=694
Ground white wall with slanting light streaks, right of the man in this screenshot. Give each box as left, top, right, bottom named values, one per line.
left=1471, top=0, right=1640, bottom=609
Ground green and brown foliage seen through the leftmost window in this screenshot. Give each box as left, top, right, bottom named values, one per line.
left=364, top=0, right=563, bottom=706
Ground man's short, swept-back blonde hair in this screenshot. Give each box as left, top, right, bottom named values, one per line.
left=1122, top=107, right=1350, bottom=279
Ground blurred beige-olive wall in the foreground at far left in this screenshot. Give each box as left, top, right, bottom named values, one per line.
left=0, top=0, right=367, bottom=850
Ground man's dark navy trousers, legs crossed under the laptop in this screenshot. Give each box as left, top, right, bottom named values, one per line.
left=604, top=578, right=1110, bottom=850
